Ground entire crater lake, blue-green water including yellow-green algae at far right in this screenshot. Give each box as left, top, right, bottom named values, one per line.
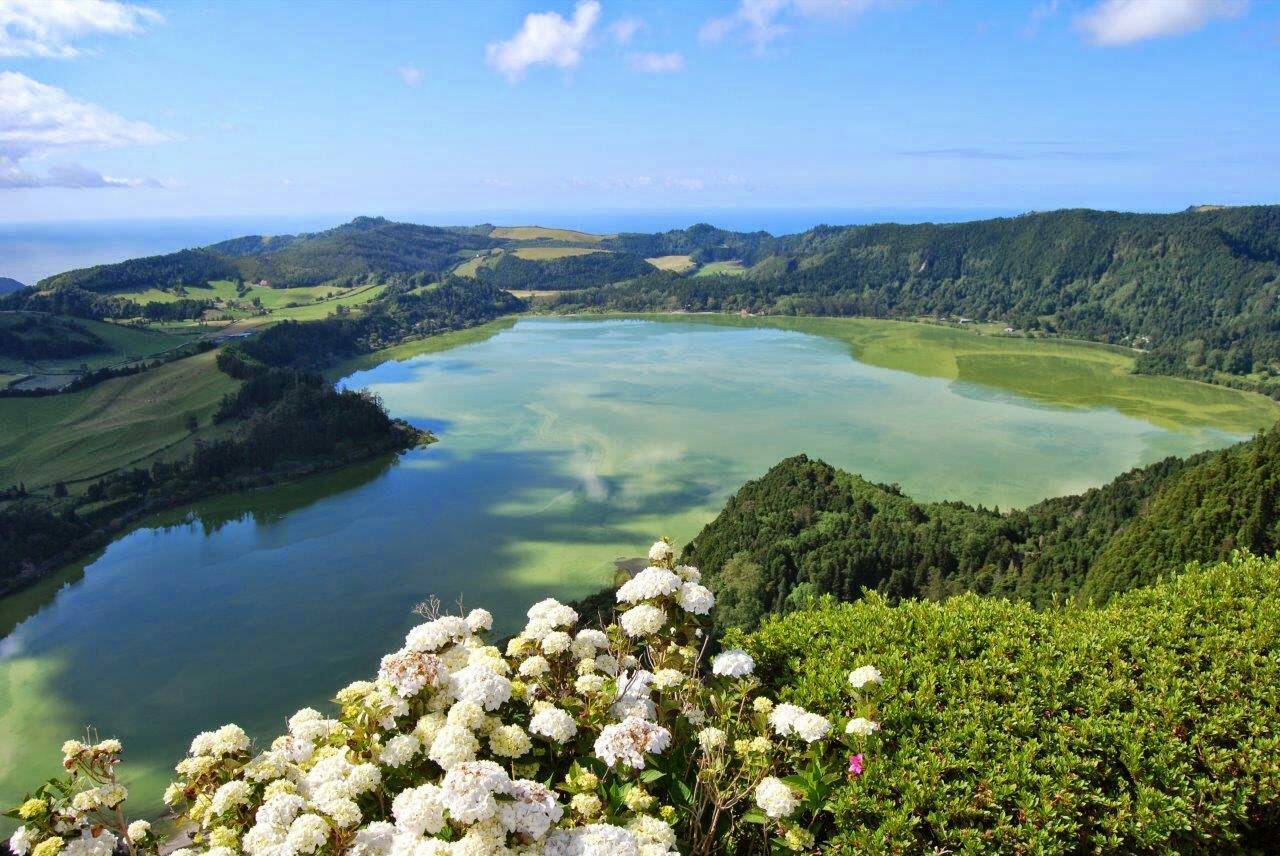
left=0, top=317, right=1275, bottom=828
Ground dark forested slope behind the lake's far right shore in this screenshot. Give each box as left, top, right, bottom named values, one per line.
left=570, top=206, right=1280, bottom=379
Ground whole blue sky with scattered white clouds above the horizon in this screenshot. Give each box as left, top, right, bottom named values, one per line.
left=0, top=0, right=1280, bottom=221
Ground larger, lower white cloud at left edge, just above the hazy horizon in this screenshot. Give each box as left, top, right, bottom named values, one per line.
left=0, top=72, right=173, bottom=187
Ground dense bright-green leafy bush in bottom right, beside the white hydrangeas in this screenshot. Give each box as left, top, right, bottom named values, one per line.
left=735, top=554, right=1280, bottom=853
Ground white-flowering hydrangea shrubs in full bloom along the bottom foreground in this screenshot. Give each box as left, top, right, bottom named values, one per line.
left=9, top=541, right=881, bottom=856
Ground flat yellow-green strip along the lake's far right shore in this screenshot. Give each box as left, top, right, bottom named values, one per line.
left=588, top=315, right=1280, bottom=435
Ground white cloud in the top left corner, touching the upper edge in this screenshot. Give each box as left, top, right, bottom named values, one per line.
left=0, top=0, right=164, bottom=59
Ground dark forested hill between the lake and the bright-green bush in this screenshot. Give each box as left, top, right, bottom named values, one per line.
left=684, top=429, right=1280, bottom=627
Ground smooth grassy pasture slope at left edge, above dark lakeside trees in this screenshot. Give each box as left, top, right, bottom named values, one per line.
left=0, top=351, right=239, bottom=487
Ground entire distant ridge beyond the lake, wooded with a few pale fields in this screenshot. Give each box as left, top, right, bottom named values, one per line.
left=22, top=206, right=1280, bottom=392
